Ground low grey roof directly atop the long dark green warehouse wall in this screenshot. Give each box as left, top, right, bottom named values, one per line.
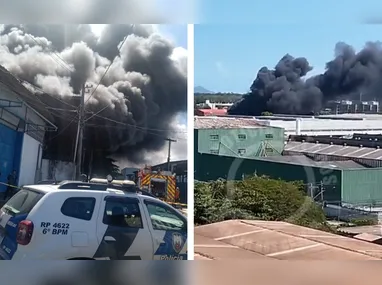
left=258, top=155, right=365, bottom=169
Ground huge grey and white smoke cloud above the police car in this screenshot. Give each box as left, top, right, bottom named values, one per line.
left=0, top=25, right=187, bottom=163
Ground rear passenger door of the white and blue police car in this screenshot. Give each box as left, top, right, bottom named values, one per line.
left=94, top=196, right=153, bottom=260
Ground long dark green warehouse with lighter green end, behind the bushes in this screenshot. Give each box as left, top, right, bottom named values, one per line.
left=194, top=154, right=382, bottom=207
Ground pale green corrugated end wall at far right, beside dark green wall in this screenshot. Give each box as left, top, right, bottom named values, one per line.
left=342, top=168, right=382, bottom=206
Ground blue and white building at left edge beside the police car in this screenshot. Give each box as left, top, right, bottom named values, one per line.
left=0, top=66, right=57, bottom=192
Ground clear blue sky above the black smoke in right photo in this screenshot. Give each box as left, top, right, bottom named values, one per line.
left=194, top=24, right=382, bottom=92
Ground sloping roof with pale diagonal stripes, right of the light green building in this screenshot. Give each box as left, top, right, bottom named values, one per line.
left=284, top=142, right=382, bottom=160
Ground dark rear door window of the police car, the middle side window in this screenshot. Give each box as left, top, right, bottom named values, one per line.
left=103, top=197, right=143, bottom=229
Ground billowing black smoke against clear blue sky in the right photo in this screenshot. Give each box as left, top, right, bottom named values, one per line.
left=229, top=42, right=382, bottom=115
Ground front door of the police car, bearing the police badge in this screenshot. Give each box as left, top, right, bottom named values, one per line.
left=144, top=199, right=187, bottom=260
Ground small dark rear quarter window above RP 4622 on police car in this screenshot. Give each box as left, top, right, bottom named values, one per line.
left=61, top=197, right=96, bottom=221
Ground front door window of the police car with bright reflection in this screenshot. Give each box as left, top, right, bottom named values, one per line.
left=146, top=201, right=187, bottom=231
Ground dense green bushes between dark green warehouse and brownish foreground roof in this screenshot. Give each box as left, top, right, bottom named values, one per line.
left=195, top=176, right=328, bottom=229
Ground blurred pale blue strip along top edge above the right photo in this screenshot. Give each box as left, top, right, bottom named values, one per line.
left=195, top=0, right=382, bottom=24
